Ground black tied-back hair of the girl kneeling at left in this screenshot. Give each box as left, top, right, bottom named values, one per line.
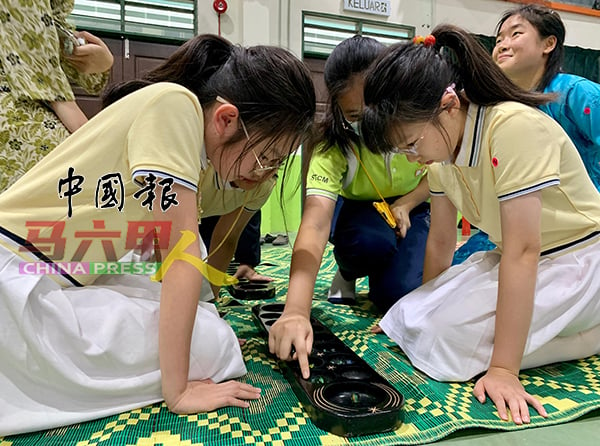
left=103, top=34, right=316, bottom=178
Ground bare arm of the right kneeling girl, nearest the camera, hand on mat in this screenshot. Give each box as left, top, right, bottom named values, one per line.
left=474, top=191, right=546, bottom=424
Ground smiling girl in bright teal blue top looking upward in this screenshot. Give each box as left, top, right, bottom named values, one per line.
left=455, top=5, right=600, bottom=261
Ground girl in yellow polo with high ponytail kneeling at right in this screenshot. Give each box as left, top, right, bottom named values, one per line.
left=362, top=25, right=600, bottom=424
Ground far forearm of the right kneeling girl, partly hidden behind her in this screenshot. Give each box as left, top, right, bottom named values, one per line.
left=423, top=196, right=456, bottom=283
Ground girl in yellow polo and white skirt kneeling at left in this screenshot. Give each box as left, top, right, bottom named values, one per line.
left=0, top=35, right=315, bottom=436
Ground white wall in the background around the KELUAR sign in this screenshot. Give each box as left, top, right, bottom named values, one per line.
left=203, top=0, right=600, bottom=51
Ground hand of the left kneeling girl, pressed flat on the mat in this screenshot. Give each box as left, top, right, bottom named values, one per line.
left=167, top=379, right=261, bottom=414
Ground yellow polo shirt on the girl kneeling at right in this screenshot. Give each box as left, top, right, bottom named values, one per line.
left=428, top=102, right=600, bottom=254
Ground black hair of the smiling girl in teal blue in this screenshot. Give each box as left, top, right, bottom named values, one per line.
left=496, top=5, right=566, bottom=91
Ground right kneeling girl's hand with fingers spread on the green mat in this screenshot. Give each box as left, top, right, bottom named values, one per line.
left=473, top=367, right=548, bottom=424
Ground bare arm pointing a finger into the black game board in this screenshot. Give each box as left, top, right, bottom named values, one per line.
left=269, top=195, right=335, bottom=378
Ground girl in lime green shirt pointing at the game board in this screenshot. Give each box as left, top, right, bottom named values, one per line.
left=270, top=36, right=429, bottom=377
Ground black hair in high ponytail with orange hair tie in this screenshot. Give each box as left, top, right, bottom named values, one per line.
left=361, top=25, right=553, bottom=153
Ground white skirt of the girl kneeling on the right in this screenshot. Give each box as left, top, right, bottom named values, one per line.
left=380, top=240, right=600, bottom=381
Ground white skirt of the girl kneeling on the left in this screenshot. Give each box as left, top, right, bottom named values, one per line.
left=0, top=247, right=246, bottom=436
